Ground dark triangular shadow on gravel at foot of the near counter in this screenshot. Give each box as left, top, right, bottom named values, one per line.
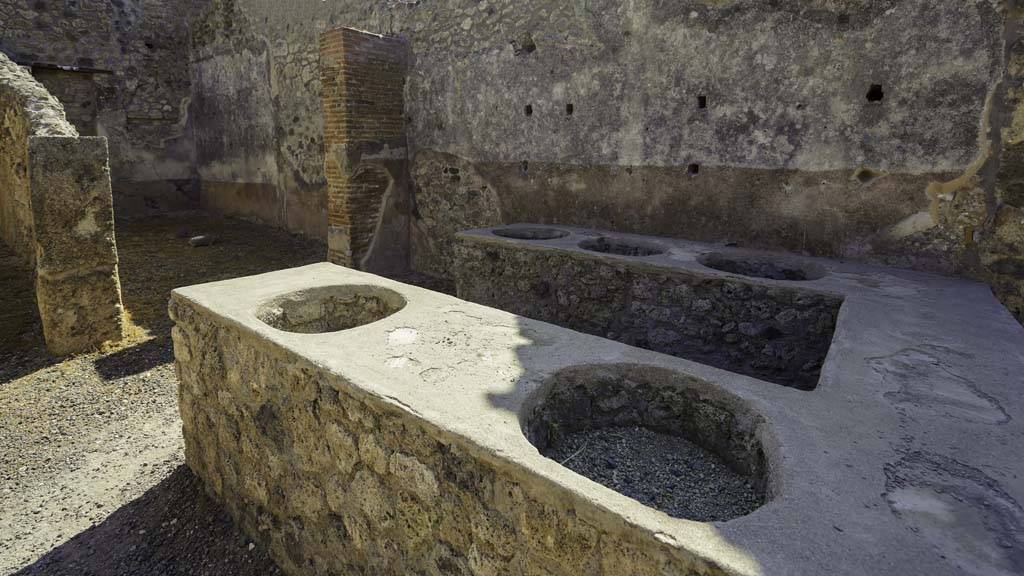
left=15, top=465, right=282, bottom=576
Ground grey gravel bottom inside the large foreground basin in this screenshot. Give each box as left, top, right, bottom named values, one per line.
left=544, top=427, right=761, bottom=522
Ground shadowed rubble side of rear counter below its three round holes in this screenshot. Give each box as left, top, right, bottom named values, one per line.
left=455, top=229, right=843, bottom=389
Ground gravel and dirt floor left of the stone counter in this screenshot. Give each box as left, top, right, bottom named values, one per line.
left=0, top=214, right=409, bottom=576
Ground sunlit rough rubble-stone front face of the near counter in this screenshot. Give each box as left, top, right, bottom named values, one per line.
left=170, top=297, right=725, bottom=576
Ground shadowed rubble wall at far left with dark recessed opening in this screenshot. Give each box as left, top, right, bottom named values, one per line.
left=0, top=0, right=199, bottom=215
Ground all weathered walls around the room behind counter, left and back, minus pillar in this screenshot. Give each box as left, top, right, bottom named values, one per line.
left=0, top=0, right=1024, bottom=318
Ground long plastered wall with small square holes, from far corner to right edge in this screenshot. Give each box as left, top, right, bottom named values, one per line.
left=186, top=0, right=1024, bottom=319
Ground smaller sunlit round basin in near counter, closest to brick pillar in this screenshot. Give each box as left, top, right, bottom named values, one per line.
left=256, top=286, right=406, bottom=334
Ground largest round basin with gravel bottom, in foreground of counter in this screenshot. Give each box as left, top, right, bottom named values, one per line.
left=522, top=364, right=768, bottom=522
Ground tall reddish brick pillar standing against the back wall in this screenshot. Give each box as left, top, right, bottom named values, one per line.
left=321, top=28, right=408, bottom=270
